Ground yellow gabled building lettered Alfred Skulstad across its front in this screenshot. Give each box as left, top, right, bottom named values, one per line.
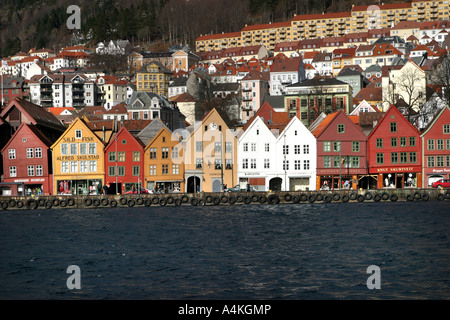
left=50, top=118, right=105, bottom=195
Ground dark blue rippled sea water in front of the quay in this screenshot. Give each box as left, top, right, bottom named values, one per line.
left=0, top=202, right=450, bottom=300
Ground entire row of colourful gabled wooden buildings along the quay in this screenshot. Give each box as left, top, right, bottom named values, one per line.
left=1, top=100, right=450, bottom=195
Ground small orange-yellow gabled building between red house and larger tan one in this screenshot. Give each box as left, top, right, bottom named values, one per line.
left=144, top=126, right=185, bottom=193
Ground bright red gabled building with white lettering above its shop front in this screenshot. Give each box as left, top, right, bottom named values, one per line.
left=368, top=105, right=422, bottom=189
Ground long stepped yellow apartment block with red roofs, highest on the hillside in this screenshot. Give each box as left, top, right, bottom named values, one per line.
left=196, top=0, right=450, bottom=52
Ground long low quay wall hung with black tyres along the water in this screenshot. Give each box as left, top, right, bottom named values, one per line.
left=0, top=188, right=450, bottom=210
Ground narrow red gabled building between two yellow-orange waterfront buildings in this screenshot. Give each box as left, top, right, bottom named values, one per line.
left=105, top=126, right=145, bottom=194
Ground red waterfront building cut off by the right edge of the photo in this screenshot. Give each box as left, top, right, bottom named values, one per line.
left=421, top=107, right=450, bottom=187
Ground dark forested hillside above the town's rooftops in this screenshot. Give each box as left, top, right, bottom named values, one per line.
left=0, top=0, right=404, bottom=57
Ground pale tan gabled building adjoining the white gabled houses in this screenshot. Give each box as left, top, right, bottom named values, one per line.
left=184, top=109, right=239, bottom=192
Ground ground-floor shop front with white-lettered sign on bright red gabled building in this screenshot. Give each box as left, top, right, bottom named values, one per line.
left=374, top=166, right=422, bottom=189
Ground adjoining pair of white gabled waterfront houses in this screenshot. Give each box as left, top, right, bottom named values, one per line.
left=238, top=109, right=317, bottom=191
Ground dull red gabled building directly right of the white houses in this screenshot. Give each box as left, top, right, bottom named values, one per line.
left=312, top=110, right=370, bottom=189
